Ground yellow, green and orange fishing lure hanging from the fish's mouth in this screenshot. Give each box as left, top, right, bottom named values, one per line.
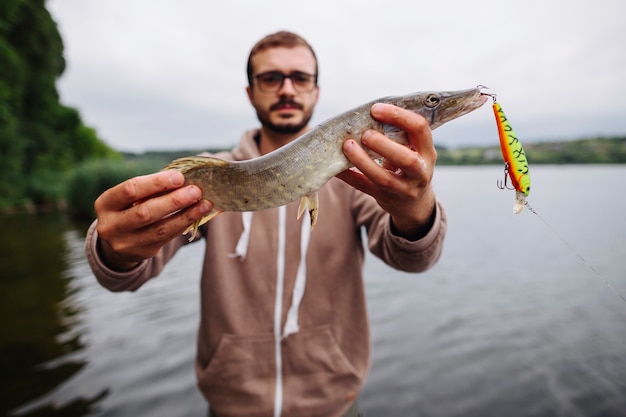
left=492, top=98, right=530, bottom=214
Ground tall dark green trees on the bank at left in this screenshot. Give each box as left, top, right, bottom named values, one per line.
left=0, top=0, right=118, bottom=208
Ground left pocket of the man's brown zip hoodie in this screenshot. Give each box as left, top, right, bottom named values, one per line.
left=198, top=334, right=276, bottom=416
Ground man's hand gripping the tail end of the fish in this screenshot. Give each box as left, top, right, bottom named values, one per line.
left=94, top=171, right=212, bottom=271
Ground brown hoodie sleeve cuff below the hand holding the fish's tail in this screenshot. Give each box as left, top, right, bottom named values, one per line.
left=85, top=220, right=186, bottom=292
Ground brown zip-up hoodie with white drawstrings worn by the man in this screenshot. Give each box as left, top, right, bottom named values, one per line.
left=86, top=131, right=446, bottom=417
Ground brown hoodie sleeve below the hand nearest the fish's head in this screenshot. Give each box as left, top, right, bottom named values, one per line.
left=354, top=188, right=447, bottom=272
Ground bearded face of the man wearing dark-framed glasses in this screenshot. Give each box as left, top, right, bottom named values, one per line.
left=247, top=46, right=319, bottom=133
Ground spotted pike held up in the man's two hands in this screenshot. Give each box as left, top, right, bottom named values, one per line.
left=163, top=86, right=488, bottom=240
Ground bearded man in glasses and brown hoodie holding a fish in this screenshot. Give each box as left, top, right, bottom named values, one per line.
left=86, top=32, right=446, bottom=417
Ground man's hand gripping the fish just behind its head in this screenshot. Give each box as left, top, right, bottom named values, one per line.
left=337, top=103, right=437, bottom=240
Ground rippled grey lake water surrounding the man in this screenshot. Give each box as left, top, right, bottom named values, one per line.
left=0, top=166, right=626, bottom=417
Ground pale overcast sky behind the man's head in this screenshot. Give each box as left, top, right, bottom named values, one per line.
left=47, top=0, right=626, bottom=151
